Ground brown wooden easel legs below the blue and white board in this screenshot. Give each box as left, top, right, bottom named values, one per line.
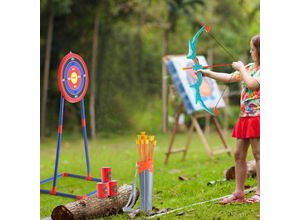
left=165, top=103, right=231, bottom=165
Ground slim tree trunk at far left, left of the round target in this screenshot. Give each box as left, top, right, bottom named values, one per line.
left=40, top=13, right=54, bottom=139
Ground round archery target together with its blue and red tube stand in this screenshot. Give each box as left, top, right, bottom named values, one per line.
left=40, top=52, right=101, bottom=199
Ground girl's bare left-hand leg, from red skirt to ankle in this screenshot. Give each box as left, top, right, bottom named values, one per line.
left=234, top=139, right=250, bottom=193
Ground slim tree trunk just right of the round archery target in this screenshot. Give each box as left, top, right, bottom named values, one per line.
left=90, top=6, right=100, bottom=140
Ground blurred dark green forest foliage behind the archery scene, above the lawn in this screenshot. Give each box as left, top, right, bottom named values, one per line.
left=40, top=0, right=260, bottom=136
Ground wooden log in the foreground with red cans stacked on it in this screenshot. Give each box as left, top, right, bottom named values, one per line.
left=51, top=184, right=139, bottom=220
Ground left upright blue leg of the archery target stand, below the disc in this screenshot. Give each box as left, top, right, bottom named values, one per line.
left=52, top=95, right=65, bottom=193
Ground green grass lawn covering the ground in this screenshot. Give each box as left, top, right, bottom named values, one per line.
left=40, top=132, right=260, bottom=220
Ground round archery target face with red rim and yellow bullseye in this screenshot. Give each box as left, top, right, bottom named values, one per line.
left=58, top=52, right=88, bottom=103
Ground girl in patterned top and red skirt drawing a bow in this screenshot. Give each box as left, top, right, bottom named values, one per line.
left=200, top=35, right=260, bottom=204
